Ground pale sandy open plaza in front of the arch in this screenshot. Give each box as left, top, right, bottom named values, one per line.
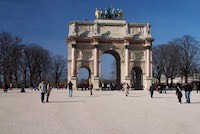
left=0, top=89, right=200, bottom=134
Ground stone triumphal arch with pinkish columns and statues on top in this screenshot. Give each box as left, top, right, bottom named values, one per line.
left=66, top=9, right=153, bottom=90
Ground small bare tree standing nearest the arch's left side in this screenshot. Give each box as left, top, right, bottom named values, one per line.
left=51, top=55, right=66, bottom=86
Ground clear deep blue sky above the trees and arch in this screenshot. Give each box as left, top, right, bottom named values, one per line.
left=0, top=0, right=200, bottom=79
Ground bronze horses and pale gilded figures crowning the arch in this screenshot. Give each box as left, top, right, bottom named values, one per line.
left=95, top=7, right=123, bottom=20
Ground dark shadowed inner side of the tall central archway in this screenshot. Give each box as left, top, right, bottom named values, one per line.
left=100, top=50, right=121, bottom=89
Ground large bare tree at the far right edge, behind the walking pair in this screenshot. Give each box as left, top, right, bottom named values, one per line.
left=174, top=35, right=200, bottom=82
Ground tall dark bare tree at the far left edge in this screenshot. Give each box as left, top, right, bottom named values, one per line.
left=0, top=32, right=22, bottom=85
